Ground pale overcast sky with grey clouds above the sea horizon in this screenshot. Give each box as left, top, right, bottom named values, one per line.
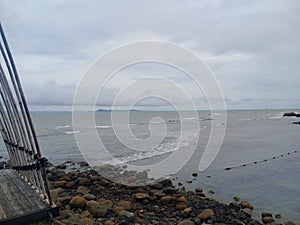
left=0, top=0, right=300, bottom=109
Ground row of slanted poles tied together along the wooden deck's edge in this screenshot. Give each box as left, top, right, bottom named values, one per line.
left=0, top=22, right=53, bottom=205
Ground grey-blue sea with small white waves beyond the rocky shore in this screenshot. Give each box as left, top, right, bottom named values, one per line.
left=0, top=109, right=300, bottom=224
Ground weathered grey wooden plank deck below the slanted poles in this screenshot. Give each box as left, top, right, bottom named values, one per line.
left=0, top=169, right=58, bottom=225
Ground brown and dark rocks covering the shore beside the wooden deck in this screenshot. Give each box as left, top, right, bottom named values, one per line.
left=41, top=162, right=291, bottom=225
